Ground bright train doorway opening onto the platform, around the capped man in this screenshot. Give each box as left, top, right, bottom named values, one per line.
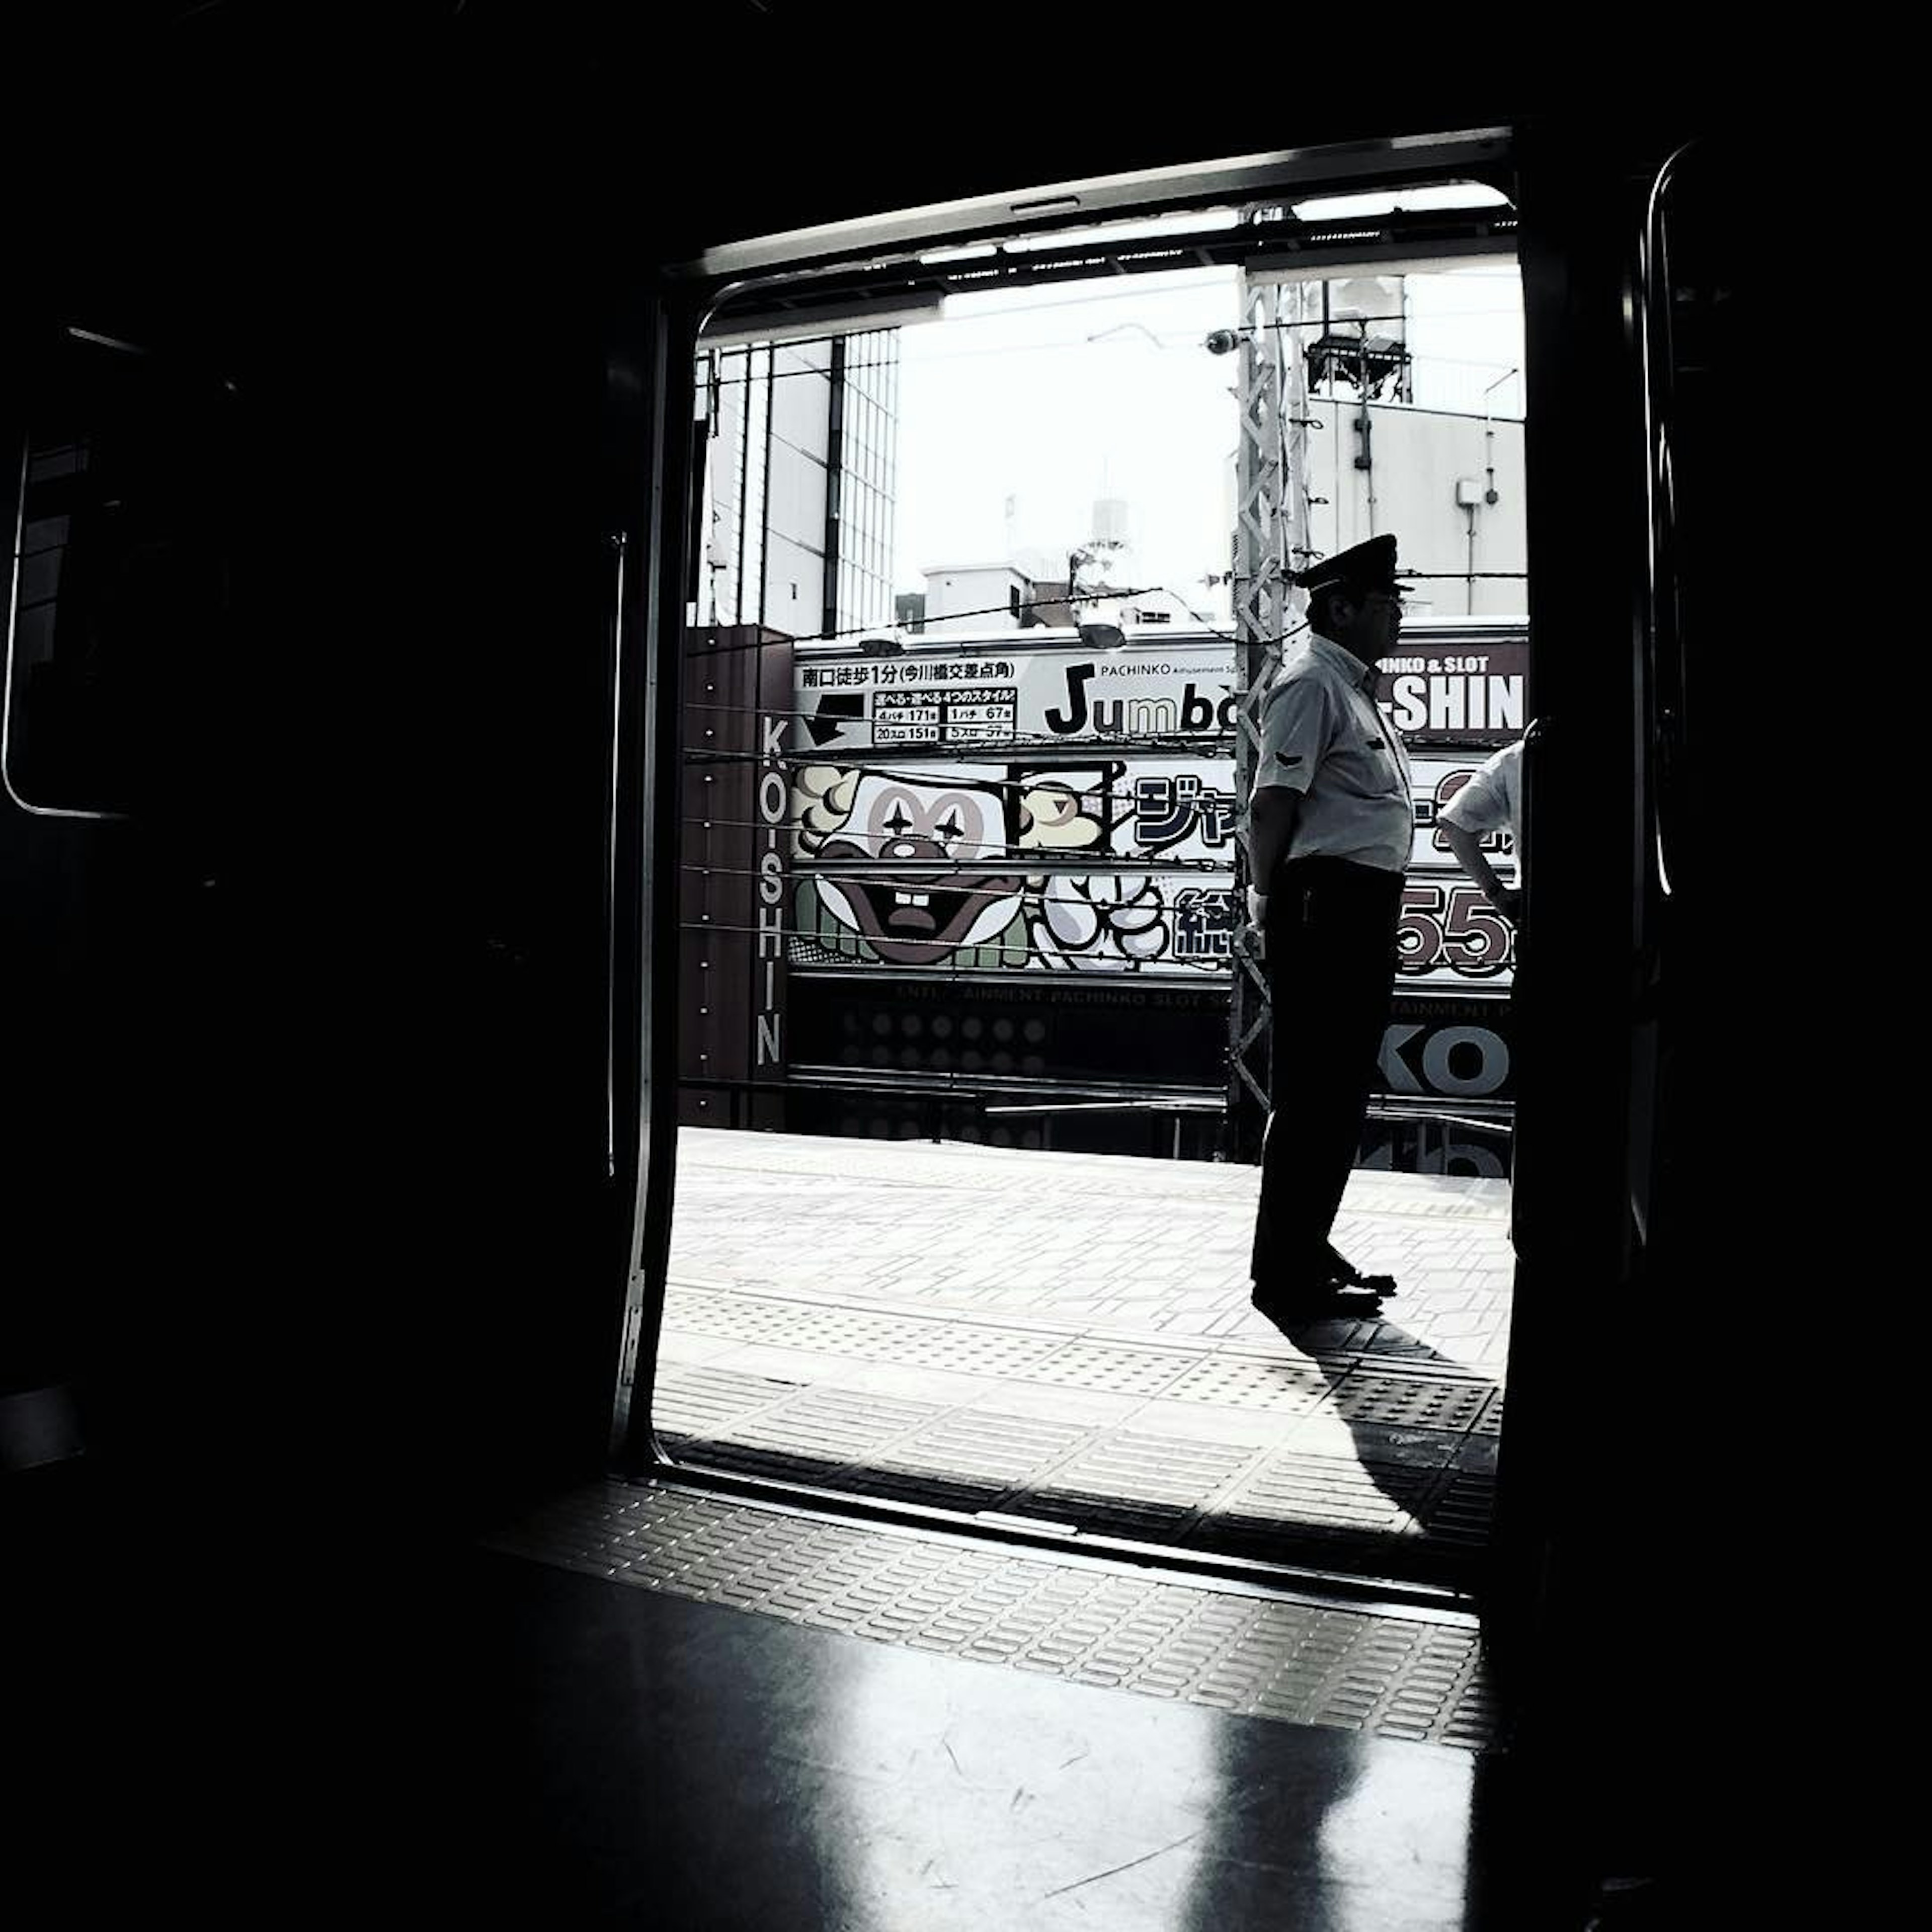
left=630, top=135, right=1528, bottom=1601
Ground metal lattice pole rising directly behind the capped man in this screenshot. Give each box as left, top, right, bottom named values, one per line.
left=1214, top=276, right=1310, bottom=1161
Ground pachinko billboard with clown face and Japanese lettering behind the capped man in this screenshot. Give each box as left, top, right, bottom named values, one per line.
left=786, top=639, right=1520, bottom=985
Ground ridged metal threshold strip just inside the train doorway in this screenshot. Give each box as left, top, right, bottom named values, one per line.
left=479, top=1482, right=1497, bottom=1750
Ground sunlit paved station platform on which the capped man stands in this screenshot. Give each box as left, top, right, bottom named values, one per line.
left=653, top=1130, right=1511, bottom=1588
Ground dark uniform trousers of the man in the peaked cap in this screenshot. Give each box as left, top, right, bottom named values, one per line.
left=1254, top=858, right=1403, bottom=1289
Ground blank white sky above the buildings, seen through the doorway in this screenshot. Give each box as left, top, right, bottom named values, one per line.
left=895, top=263, right=1522, bottom=622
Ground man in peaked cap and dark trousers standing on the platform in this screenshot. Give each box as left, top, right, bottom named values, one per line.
left=1248, top=537, right=1414, bottom=1320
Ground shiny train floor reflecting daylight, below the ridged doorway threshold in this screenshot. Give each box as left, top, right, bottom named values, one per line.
left=463, top=1530, right=1522, bottom=1932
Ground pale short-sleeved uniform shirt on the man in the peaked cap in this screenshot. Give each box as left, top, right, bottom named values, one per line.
left=1254, top=632, right=1414, bottom=873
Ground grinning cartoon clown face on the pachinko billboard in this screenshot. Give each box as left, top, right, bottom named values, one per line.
left=817, top=771, right=1024, bottom=966
